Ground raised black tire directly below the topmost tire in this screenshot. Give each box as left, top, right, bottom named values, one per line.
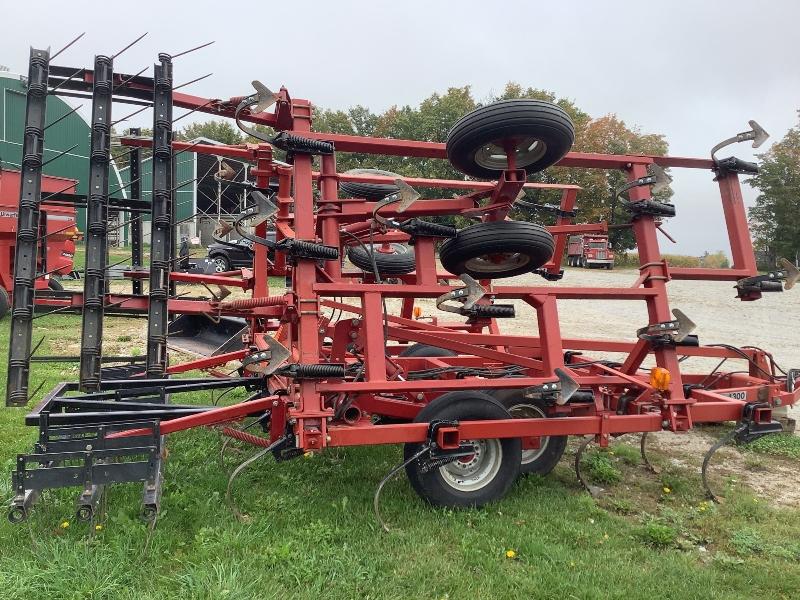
left=439, top=221, right=555, bottom=279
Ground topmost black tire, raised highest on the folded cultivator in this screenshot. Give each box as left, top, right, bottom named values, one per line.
left=446, top=98, right=575, bottom=179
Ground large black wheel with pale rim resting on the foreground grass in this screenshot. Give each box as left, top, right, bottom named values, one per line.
left=404, top=390, right=522, bottom=508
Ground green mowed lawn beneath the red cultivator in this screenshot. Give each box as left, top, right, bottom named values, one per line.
left=0, top=315, right=800, bottom=600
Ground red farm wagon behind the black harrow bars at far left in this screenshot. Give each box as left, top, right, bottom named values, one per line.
left=0, top=169, right=80, bottom=317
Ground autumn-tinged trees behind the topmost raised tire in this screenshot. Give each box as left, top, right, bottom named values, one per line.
left=314, top=82, right=671, bottom=248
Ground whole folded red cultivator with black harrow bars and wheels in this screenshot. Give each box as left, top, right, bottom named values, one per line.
left=6, top=42, right=800, bottom=521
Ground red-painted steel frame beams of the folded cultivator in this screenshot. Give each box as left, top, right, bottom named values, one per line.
left=47, top=72, right=800, bottom=450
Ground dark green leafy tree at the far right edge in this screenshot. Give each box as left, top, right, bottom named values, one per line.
left=748, top=116, right=800, bottom=266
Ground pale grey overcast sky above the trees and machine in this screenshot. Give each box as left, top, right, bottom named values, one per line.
left=0, top=0, right=800, bottom=254
